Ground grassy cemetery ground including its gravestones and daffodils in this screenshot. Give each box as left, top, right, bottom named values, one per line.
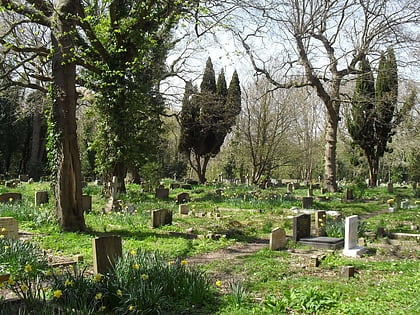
left=0, top=179, right=420, bottom=314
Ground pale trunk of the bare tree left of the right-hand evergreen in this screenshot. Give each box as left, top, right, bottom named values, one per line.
left=324, top=111, right=339, bottom=192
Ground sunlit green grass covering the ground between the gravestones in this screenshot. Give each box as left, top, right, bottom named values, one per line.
left=0, top=183, right=420, bottom=314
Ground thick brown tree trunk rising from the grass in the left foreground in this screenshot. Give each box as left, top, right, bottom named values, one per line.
left=51, top=0, right=86, bottom=231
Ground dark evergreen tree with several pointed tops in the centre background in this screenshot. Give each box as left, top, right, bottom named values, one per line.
left=179, top=58, right=241, bottom=183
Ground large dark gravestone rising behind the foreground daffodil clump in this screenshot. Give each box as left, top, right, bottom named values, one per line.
left=92, top=236, right=122, bottom=274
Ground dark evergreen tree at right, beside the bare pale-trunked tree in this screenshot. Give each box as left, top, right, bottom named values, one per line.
left=347, top=49, right=402, bottom=186
